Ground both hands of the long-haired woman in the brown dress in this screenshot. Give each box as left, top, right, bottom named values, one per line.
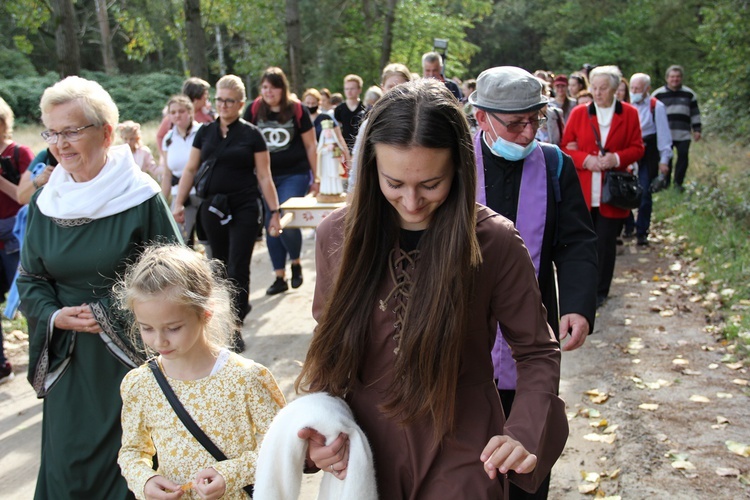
left=297, top=427, right=537, bottom=480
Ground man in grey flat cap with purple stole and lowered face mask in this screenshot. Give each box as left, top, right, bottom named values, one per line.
left=469, top=66, right=598, bottom=499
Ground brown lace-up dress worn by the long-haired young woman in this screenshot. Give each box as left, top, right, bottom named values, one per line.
left=313, top=206, right=568, bottom=500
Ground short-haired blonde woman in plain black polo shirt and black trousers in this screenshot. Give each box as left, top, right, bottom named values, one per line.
left=172, top=75, right=281, bottom=352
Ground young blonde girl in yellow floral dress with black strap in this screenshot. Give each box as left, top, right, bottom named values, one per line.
left=117, top=245, right=285, bottom=499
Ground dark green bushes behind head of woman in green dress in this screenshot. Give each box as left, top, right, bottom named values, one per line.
left=0, top=71, right=183, bottom=123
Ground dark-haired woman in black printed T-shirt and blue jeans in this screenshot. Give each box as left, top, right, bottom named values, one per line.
left=244, top=67, right=320, bottom=295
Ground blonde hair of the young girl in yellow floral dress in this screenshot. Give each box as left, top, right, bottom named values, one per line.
left=114, top=244, right=235, bottom=353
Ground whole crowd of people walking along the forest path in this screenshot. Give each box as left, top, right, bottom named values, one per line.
left=0, top=52, right=701, bottom=499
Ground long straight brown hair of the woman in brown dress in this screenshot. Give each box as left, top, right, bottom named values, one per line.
left=296, top=80, right=482, bottom=445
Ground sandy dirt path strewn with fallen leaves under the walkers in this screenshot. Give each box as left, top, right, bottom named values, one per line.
left=0, top=229, right=750, bottom=499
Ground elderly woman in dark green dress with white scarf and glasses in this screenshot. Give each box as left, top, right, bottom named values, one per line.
left=18, top=77, right=180, bottom=499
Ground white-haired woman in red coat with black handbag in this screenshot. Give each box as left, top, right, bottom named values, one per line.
left=560, top=66, right=644, bottom=307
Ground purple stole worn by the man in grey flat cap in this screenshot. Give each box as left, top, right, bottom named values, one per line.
left=474, top=130, right=547, bottom=390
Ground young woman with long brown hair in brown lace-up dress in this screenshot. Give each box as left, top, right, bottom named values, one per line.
left=290, top=80, right=567, bottom=500
